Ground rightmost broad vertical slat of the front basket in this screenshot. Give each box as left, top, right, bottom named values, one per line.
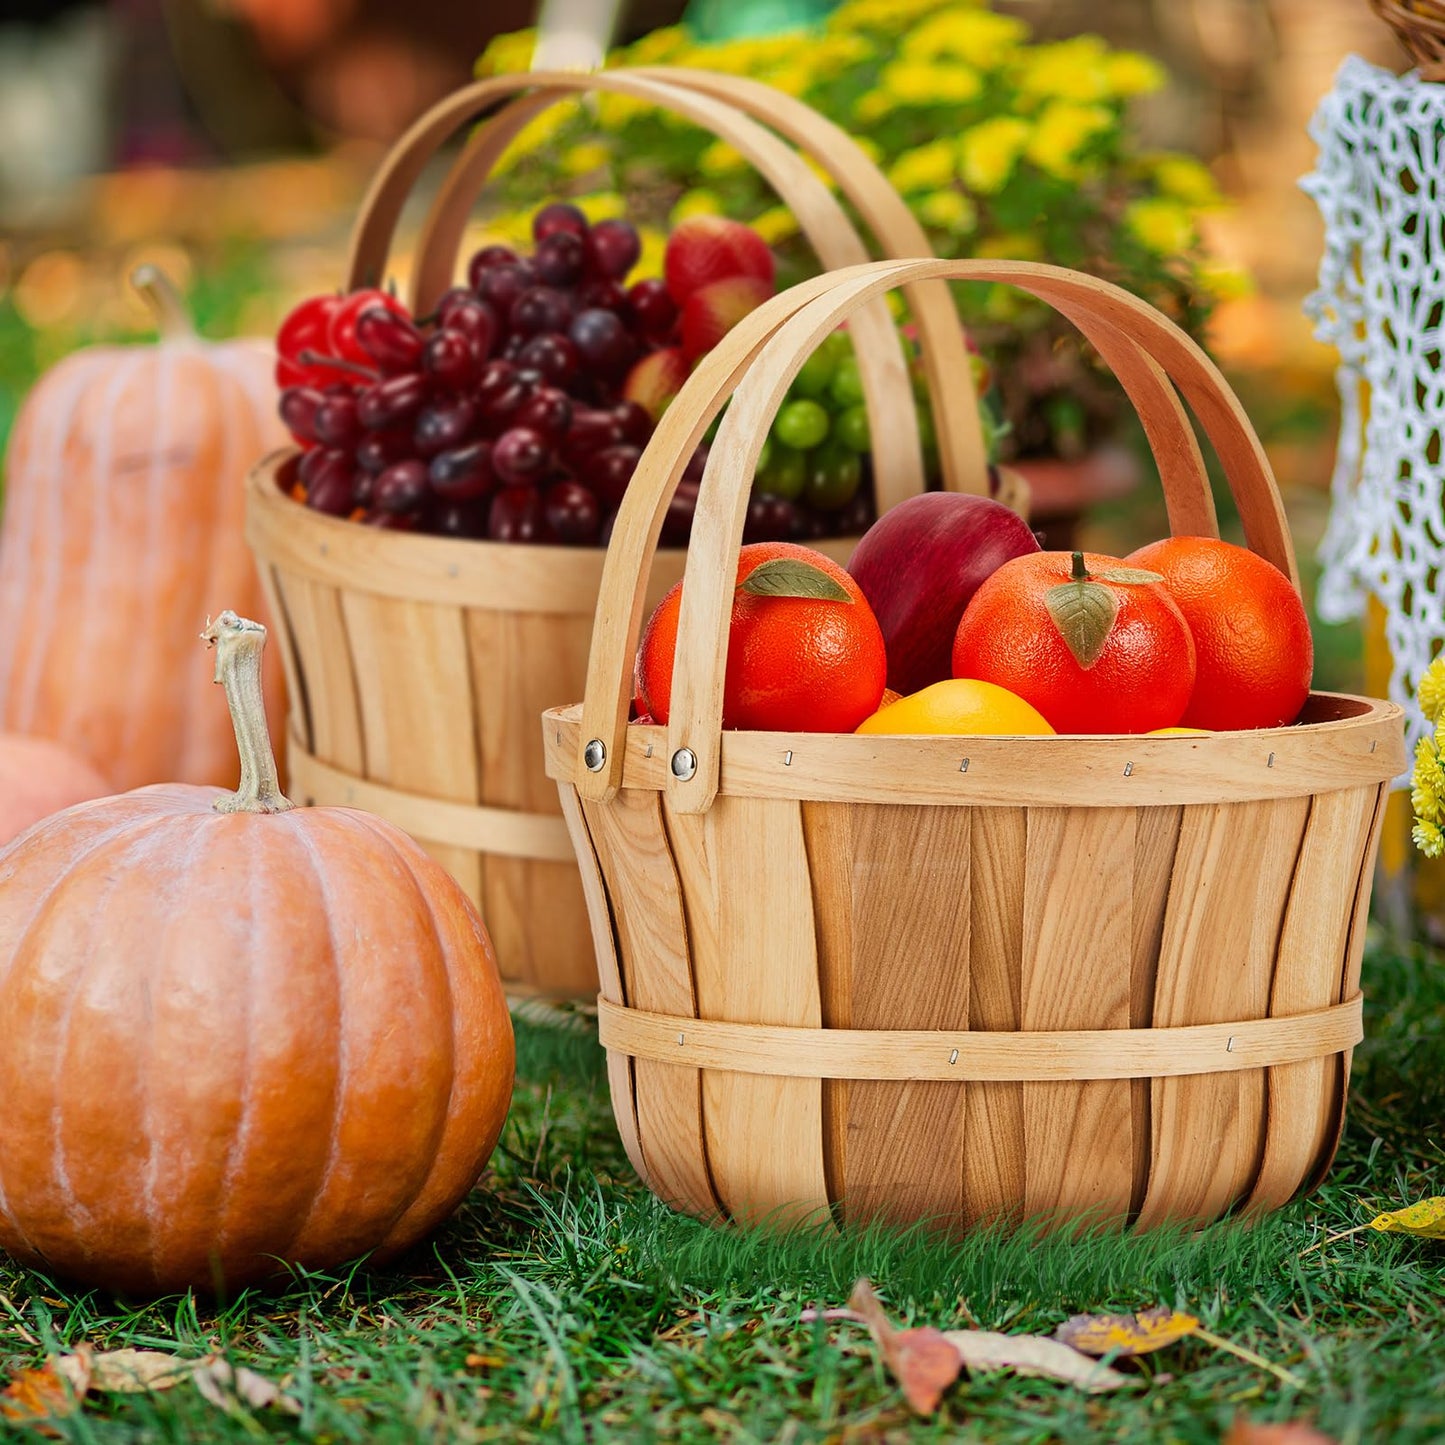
left=1248, top=788, right=1377, bottom=1209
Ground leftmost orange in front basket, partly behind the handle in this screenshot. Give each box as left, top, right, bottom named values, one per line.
left=636, top=542, right=889, bottom=733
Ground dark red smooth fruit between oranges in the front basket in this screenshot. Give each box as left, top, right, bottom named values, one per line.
left=848, top=491, right=1039, bottom=696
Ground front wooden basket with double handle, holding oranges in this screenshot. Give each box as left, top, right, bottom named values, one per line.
left=543, top=262, right=1405, bottom=1225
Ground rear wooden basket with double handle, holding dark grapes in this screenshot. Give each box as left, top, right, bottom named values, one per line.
left=247, top=69, right=994, bottom=997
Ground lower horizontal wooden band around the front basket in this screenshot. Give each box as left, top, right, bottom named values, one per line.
left=597, top=993, right=1364, bottom=1084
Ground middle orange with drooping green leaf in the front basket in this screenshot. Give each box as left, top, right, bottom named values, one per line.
left=954, top=552, right=1194, bottom=733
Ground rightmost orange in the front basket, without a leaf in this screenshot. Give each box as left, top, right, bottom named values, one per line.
left=1129, top=538, right=1315, bottom=731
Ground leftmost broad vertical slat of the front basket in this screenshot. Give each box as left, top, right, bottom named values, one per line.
left=582, top=792, right=718, bottom=1217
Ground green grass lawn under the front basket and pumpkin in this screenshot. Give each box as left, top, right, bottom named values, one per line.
left=0, top=944, right=1445, bottom=1445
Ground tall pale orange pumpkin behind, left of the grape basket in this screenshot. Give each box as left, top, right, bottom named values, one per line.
left=0, top=267, right=286, bottom=788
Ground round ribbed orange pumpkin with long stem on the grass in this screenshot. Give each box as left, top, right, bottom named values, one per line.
left=0, top=613, right=513, bottom=1293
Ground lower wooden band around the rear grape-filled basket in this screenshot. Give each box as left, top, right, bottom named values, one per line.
left=286, top=728, right=577, bottom=864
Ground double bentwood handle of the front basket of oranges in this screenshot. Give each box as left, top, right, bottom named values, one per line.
left=577, top=260, right=1299, bottom=812
